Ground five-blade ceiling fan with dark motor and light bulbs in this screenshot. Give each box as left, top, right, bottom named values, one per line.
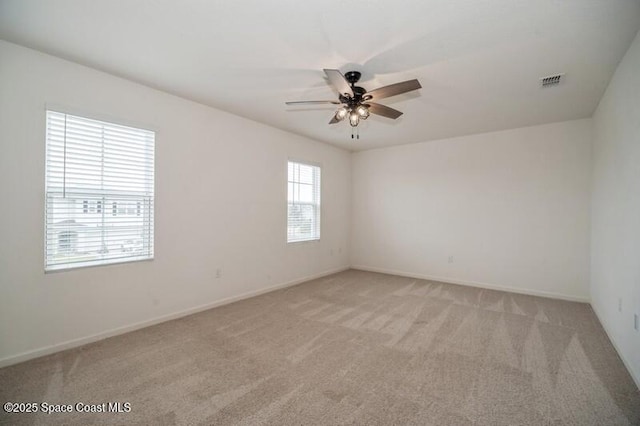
left=286, top=69, right=422, bottom=130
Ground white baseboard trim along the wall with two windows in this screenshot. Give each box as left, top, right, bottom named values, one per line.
left=0, top=266, right=350, bottom=368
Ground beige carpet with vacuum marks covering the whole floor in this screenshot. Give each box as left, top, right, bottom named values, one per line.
left=0, top=270, right=640, bottom=426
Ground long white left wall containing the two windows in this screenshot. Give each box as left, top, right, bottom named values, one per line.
left=0, top=41, right=351, bottom=365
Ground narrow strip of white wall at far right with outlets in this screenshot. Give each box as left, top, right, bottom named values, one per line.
left=591, top=29, right=640, bottom=386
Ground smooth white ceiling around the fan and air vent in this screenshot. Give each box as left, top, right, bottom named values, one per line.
left=0, top=0, right=640, bottom=150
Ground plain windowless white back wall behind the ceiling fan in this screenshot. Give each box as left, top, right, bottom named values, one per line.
left=351, top=119, right=591, bottom=300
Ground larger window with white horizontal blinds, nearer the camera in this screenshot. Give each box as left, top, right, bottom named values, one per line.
left=45, top=111, right=155, bottom=271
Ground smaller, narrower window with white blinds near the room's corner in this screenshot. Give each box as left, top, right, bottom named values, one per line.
left=287, top=161, right=320, bottom=243
